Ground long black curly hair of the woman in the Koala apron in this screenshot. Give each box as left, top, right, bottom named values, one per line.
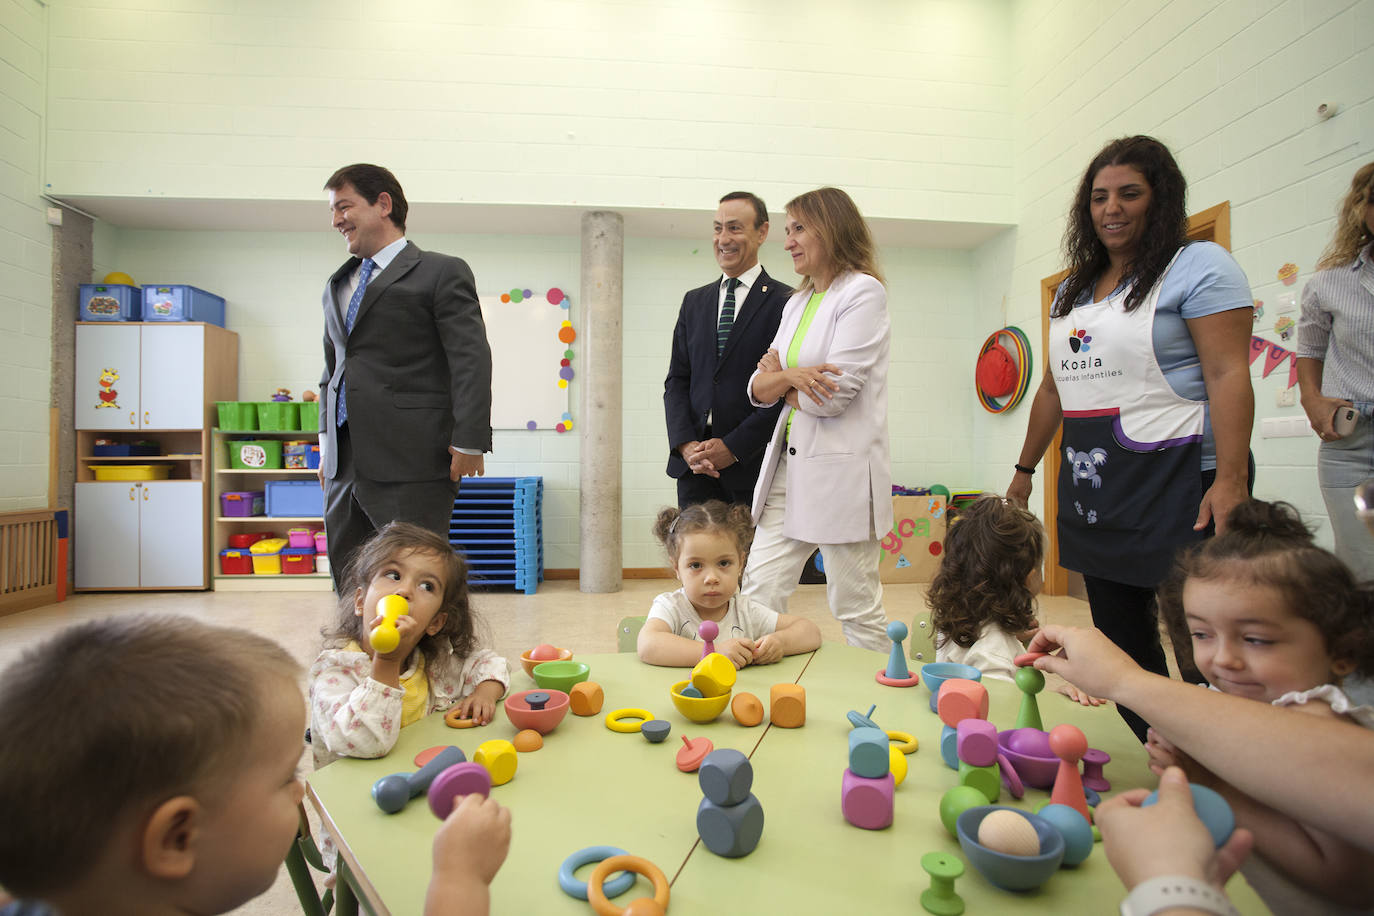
left=1050, top=136, right=1189, bottom=319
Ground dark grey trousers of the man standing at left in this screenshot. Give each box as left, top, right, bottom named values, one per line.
left=324, top=423, right=458, bottom=595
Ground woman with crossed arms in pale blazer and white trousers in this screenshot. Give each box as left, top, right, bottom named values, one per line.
left=743, top=188, right=892, bottom=651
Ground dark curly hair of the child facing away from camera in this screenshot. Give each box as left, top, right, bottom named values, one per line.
left=926, top=496, right=1044, bottom=648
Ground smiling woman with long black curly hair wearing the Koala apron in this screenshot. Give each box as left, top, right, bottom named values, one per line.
left=1007, top=136, right=1254, bottom=740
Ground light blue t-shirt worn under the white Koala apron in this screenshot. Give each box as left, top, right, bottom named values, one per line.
left=1059, top=242, right=1254, bottom=471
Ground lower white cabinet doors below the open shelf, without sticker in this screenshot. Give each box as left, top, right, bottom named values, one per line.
left=74, top=481, right=206, bottom=588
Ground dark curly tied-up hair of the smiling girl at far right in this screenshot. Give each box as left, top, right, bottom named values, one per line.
left=1157, top=500, right=1374, bottom=687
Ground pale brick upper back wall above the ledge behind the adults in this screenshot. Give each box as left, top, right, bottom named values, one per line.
left=47, top=0, right=1013, bottom=222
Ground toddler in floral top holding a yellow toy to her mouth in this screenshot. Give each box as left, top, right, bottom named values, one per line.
left=311, top=522, right=510, bottom=769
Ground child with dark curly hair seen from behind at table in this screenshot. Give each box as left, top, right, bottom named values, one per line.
left=926, top=496, right=1102, bottom=706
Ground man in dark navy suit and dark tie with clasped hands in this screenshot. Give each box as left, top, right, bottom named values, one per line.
left=664, top=191, right=791, bottom=508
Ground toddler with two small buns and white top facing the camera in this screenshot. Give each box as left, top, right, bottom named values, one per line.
left=638, top=500, right=820, bottom=667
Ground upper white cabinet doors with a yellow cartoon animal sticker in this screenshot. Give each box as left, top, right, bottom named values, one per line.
left=76, top=323, right=207, bottom=430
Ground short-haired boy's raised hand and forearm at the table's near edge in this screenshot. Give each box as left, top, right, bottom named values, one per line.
left=425, top=792, right=511, bottom=916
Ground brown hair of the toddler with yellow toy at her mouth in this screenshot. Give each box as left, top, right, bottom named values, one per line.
left=320, top=522, right=481, bottom=665
